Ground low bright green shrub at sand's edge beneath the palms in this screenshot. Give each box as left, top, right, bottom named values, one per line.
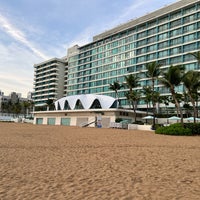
left=155, top=124, right=192, bottom=135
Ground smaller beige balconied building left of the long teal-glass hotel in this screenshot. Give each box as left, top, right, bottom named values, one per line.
left=33, top=58, right=67, bottom=107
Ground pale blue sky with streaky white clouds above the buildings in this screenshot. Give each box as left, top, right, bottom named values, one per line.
left=0, top=0, right=177, bottom=97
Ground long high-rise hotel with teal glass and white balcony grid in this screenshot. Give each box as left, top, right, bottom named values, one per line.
left=33, top=0, right=200, bottom=108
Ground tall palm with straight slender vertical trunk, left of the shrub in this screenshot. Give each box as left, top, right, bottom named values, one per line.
left=146, top=62, right=162, bottom=128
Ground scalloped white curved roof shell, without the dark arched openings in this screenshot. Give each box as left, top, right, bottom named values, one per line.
left=55, top=94, right=116, bottom=110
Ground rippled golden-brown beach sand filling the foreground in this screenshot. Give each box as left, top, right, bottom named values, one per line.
left=0, top=123, right=200, bottom=200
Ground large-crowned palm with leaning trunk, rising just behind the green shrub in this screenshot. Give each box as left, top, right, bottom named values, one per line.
left=159, top=65, right=185, bottom=124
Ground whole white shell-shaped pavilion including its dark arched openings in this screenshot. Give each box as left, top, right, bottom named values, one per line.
left=55, top=94, right=118, bottom=110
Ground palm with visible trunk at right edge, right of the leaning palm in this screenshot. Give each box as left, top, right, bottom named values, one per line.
left=182, top=70, right=200, bottom=123
